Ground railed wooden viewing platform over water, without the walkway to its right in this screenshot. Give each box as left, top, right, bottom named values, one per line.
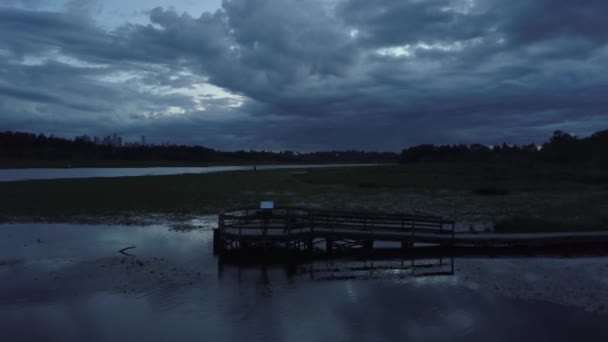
left=214, top=207, right=454, bottom=255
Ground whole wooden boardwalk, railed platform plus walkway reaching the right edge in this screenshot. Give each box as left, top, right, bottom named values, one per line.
left=213, top=207, right=608, bottom=255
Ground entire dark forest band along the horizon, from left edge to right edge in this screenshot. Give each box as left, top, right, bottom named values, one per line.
left=0, top=130, right=608, bottom=167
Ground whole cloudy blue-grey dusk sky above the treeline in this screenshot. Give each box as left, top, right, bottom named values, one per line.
left=0, top=0, right=608, bottom=151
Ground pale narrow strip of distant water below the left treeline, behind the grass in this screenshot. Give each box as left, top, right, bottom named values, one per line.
left=0, top=164, right=373, bottom=182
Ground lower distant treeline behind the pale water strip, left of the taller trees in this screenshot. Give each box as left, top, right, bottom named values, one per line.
left=0, top=131, right=398, bottom=165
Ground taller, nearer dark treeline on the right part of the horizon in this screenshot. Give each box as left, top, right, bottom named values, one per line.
left=400, top=130, right=608, bottom=167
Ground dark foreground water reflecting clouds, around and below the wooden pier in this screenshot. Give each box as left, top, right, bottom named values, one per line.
left=0, top=220, right=608, bottom=342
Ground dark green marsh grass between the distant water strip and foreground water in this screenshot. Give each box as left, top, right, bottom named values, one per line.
left=0, top=164, right=608, bottom=232
